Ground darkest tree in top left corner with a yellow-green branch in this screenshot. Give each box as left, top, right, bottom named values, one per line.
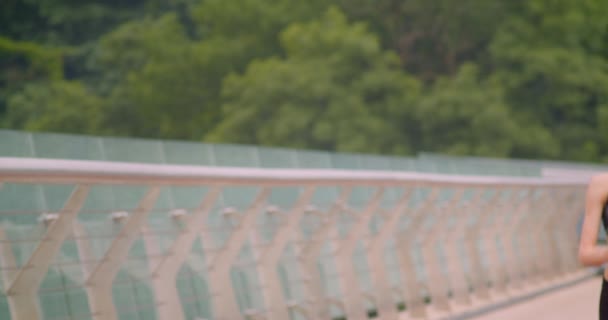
left=0, top=0, right=196, bottom=130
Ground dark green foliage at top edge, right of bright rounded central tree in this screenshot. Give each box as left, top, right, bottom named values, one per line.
left=338, top=0, right=522, bottom=83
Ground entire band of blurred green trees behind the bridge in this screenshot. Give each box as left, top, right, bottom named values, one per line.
left=0, top=0, right=608, bottom=161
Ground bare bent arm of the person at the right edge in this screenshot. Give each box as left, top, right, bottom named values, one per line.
left=578, top=175, right=608, bottom=266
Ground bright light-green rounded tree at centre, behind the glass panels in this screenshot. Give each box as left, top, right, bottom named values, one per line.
left=209, top=8, right=419, bottom=153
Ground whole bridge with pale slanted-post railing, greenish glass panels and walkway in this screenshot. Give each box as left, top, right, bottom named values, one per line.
left=0, top=131, right=603, bottom=320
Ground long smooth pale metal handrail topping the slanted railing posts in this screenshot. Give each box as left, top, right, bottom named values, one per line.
left=0, top=157, right=589, bottom=187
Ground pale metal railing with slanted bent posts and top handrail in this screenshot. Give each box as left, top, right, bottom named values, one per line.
left=0, top=158, right=587, bottom=320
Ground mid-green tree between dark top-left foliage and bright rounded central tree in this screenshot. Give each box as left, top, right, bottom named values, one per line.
left=87, top=0, right=330, bottom=139
